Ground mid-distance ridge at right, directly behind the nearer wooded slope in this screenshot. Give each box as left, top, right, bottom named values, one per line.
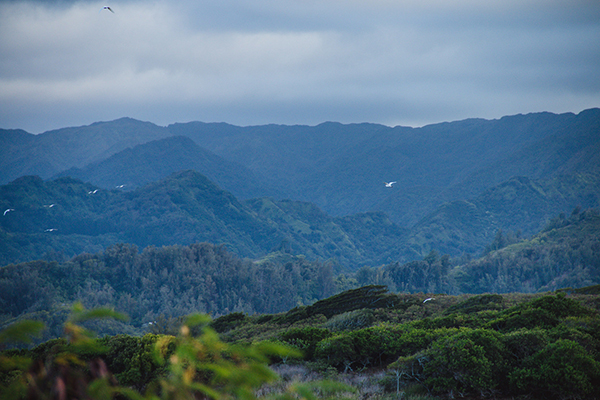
left=405, top=174, right=600, bottom=256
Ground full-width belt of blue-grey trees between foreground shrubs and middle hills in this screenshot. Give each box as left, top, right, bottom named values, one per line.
left=0, top=210, right=600, bottom=338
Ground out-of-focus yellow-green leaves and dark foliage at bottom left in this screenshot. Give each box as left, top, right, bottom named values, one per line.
left=0, top=304, right=353, bottom=400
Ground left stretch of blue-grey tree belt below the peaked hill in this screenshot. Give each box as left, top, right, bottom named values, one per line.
left=0, top=243, right=336, bottom=337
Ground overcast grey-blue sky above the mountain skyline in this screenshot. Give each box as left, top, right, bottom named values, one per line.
left=0, top=0, right=600, bottom=133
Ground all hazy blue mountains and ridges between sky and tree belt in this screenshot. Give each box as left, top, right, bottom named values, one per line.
left=0, top=109, right=600, bottom=267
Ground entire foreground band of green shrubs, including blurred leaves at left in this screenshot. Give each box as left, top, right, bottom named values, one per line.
left=1, top=286, right=600, bottom=399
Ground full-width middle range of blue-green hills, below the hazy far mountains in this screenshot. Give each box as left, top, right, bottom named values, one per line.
left=0, top=167, right=600, bottom=270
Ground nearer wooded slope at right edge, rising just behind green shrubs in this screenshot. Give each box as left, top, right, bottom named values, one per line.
left=452, top=209, right=600, bottom=293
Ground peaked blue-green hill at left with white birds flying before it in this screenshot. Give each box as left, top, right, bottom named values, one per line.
left=0, top=171, right=281, bottom=264
